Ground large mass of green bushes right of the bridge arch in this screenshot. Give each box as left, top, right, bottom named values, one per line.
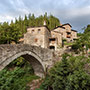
left=37, top=54, right=90, bottom=90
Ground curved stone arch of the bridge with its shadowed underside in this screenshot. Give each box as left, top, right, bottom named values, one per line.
left=0, top=51, right=45, bottom=77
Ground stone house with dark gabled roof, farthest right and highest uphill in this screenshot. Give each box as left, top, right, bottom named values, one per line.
left=53, top=23, right=77, bottom=42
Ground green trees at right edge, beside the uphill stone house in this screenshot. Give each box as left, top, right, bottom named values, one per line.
left=72, top=25, right=90, bottom=52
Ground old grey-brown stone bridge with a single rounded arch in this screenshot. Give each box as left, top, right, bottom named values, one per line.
left=0, top=44, right=60, bottom=77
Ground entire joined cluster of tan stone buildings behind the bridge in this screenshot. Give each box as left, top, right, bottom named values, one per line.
left=24, top=22, right=77, bottom=50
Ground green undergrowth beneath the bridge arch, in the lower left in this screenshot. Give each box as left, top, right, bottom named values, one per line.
left=0, top=57, right=39, bottom=90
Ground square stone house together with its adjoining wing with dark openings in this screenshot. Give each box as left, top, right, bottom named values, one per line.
left=24, top=25, right=62, bottom=50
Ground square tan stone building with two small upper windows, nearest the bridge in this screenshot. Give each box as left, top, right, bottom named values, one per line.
left=24, top=26, right=51, bottom=48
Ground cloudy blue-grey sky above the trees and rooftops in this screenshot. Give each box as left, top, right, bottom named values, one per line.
left=0, top=0, right=90, bottom=32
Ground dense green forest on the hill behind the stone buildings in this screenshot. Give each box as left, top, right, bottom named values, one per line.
left=0, top=13, right=60, bottom=44
